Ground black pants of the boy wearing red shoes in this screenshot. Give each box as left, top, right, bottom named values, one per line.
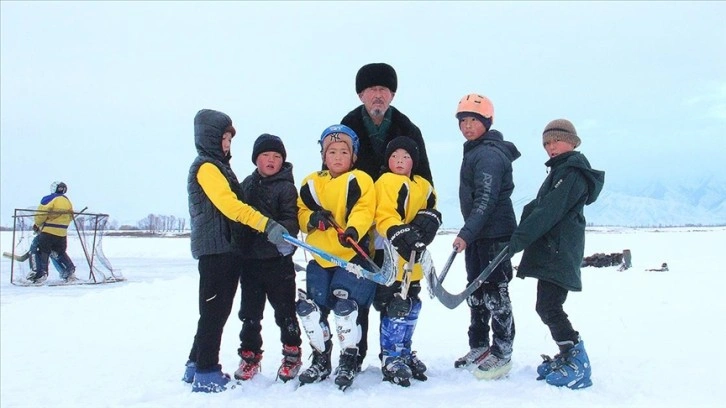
left=239, top=255, right=302, bottom=352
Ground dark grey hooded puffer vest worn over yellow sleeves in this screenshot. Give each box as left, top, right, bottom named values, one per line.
left=187, top=109, right=239, bottom=259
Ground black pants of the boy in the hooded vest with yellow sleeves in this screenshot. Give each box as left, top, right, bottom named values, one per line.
left=189, top=252, right=240, bottom=371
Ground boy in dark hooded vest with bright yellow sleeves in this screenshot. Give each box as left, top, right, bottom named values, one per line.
left=182, top=109, right=288, bottom=392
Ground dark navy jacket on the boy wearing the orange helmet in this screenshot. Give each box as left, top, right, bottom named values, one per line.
left=458, top=130, right=521, bottom=244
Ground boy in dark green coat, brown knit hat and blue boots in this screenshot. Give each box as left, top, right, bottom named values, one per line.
left=509, top=119, right=605, bottom=389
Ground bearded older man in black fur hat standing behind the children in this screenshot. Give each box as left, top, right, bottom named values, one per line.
left=340, top=62, right=441, bottom=376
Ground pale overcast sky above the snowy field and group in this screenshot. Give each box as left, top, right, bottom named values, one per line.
left=0, top=1, right=726, bottom=225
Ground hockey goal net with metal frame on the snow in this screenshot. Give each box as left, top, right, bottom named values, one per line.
left=3, top=209, right=125, bottom=286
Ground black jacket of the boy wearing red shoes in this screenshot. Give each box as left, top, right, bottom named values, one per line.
left=233, top=162, right=300, bottom=259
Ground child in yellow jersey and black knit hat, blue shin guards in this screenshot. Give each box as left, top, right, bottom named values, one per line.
left=373, top=137, right=441, bottom=387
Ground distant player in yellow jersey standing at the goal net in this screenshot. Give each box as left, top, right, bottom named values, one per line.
left=27, top=182, right=76, bottom=283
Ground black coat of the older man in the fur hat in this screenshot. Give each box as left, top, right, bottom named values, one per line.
left=340, top=105, right=433, bottom=184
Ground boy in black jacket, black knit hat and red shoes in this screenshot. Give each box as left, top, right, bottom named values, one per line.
left=233, top=133, right=302, bottom=382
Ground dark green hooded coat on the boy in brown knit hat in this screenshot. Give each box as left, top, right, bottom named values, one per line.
left=510, top=151, right=605, bottom=291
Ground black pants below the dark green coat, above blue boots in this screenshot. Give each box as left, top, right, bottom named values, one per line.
left=535, top=279, right=580, bottom=343
